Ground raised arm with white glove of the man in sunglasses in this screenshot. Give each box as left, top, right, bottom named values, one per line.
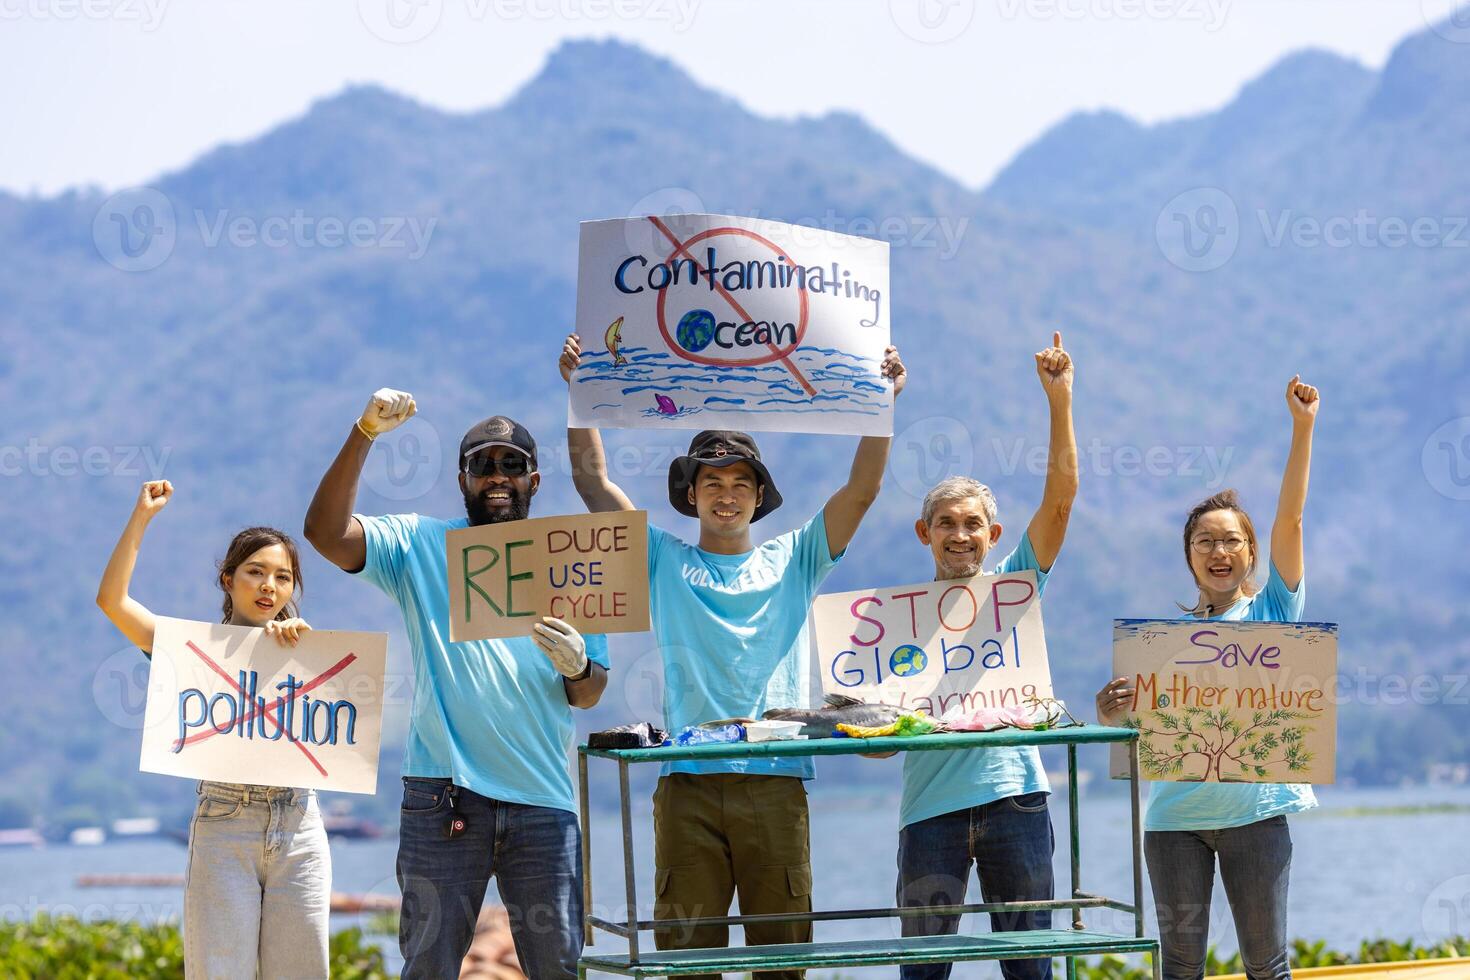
left=301, top=388, right=417, bottom=572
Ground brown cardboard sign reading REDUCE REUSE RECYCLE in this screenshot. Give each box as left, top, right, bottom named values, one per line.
left=445, top=510, right=648, bottom=644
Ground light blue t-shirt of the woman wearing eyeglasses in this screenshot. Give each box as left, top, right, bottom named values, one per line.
left=1144, top=561, right=1317, bottom=830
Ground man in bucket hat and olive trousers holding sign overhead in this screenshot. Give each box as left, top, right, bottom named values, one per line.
left=560, top=334, right=907, bottom=980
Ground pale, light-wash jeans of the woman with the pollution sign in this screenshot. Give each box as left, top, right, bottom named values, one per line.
left=184, top=782, right=332, bottom=980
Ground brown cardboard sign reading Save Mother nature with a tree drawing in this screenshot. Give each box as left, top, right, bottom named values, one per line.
left=1111, top=620, right=1338, bottom=783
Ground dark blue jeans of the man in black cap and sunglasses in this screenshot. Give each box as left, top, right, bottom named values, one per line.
left=398, top=776, right=582, bottom=980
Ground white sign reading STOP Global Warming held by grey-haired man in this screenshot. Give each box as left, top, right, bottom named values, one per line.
left=811, top=570, right=1051, bottom=717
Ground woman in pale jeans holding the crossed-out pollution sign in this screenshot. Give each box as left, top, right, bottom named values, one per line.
left=97, top=480, right=332, bottom=980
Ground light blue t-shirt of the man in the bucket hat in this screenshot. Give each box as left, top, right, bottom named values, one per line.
left=648, top=513, right=842, bottom=779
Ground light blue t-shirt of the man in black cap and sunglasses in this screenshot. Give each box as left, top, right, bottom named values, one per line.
left=356, top=514, right=609, bottom=811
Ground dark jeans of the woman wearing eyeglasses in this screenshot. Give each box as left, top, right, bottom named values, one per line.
left=1144, top=817, right=1291, bottom=980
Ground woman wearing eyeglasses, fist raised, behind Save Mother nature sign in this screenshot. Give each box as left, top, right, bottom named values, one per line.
left=1097, top=376, right=1320, bottom=980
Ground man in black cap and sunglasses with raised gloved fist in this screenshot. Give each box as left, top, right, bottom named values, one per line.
left=306, top=388, right=607, bottom=980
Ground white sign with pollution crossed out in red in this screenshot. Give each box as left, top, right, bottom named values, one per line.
left=138, top=617, right=388, bottom=793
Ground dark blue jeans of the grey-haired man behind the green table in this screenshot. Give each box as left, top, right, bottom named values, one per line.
left=898, top=793, right=1055, bottom=980
